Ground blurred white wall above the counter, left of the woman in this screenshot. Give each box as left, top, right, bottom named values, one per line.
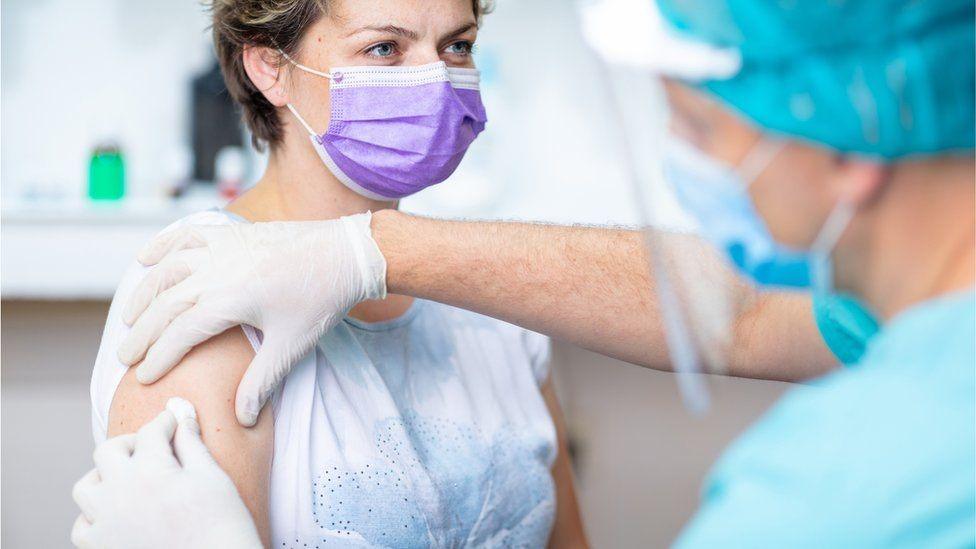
left=0, top=0, right=209, bottom=199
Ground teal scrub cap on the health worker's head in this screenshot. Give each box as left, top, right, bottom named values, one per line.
left=658, top=0, right=976, bottom=160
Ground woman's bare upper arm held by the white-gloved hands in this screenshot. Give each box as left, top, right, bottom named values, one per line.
left=108, top=328, right=274, bottom=545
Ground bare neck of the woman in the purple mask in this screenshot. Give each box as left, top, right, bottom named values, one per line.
left=226, top=134, right=413, bottom=322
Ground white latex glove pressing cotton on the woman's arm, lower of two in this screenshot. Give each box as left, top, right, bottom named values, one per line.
left=71, top=398, right=261, bottom=549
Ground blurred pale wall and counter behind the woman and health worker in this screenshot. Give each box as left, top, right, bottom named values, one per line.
left=0, top=0, right=783, bottom=548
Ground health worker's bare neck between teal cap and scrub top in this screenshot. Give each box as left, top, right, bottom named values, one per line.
left=838, top=158, right=976, bottom=321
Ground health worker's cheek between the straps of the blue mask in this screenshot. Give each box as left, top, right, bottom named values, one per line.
left=749, top=158, right=827, bottom=249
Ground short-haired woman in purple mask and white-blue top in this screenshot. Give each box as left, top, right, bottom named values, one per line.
left=92, top=0, right=586, bottom=547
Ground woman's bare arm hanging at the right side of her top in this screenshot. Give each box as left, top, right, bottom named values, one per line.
left=542, top=379, right=589, bottom=549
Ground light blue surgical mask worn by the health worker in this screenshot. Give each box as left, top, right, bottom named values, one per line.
left=664, top=138, right=854, bottom=293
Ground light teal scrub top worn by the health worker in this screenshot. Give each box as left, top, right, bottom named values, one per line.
left=676, top=291, right=976, bottom=548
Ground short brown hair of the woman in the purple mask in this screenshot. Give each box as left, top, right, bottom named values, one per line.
left=209, top=0, right=490, bottom=150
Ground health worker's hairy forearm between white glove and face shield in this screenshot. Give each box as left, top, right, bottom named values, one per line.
left=373, top=212, right=668, bottom=369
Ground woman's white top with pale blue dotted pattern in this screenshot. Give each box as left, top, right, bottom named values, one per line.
left=91, top=211, right=556, bottom=548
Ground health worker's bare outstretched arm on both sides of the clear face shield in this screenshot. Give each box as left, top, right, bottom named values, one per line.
left=372, top=211, right=837, bottom=381
